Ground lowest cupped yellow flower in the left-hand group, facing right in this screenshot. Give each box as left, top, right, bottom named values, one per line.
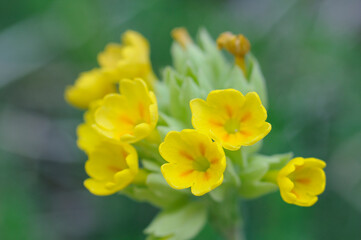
left=84, top=141, right=138, bottom=196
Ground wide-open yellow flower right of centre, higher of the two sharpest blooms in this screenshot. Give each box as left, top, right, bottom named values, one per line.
left=190, top=89, right=271, bottom=150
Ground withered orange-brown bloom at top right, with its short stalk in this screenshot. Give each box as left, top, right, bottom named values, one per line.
left=217, top=32, right=251, bottom=73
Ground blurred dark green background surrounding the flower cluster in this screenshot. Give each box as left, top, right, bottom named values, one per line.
left=0, top=0, right=361, bottom=240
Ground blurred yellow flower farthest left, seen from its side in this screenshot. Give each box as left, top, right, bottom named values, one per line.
left=65, top=69, right=116, bottom=108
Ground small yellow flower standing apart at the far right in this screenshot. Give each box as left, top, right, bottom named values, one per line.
left=277, top=157, right=326, bottom=207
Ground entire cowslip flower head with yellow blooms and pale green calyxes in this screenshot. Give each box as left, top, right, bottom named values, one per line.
left=65, top=28, right=326, bottom=239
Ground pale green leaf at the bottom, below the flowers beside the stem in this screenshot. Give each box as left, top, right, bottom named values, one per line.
left=144, top=202, right=207, bottom=240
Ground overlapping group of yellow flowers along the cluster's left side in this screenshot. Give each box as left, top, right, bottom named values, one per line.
left=65, top=31, right=158, bottom=195
